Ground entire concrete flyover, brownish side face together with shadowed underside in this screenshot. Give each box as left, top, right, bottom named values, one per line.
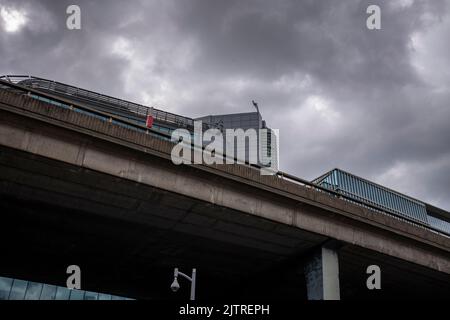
left=0, top=90, right=450, bottom=299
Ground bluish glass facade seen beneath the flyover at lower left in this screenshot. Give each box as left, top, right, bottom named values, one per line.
left=0, top=277, right=132, bottom=300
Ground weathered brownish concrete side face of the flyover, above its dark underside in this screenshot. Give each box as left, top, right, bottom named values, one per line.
left=0, top=87, right=450, bottom=273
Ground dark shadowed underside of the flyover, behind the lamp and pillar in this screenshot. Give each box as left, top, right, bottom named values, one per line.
left=0, top=148, right=450, bottom=300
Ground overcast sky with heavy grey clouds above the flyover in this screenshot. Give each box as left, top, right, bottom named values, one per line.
left=0, top=0, right=450, bottom=210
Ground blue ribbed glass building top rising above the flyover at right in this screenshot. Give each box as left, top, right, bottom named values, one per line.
left=312, top=169, right=450, bottom=234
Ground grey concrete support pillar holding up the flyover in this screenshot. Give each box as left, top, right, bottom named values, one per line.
left=304, top=246, right=340, bottom=300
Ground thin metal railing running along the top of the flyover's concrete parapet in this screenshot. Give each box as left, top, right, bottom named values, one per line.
left=0, top=76, right=450, bottom=237
